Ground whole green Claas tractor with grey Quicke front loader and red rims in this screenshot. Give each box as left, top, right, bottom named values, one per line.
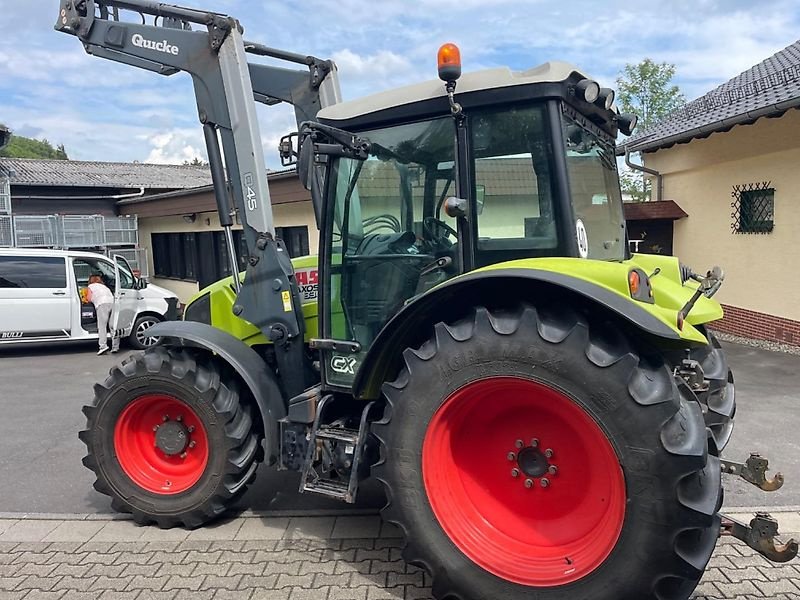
left=56, top=0, right=797, bottom=600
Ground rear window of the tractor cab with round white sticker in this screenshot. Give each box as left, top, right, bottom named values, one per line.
left=564, top=115, right=625, bottom=260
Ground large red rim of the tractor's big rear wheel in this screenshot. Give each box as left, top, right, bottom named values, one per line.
left=422, top=377, right=626, bottom=587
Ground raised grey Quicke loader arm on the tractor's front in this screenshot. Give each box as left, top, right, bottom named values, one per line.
left=55, top=0, right=339, bottom=397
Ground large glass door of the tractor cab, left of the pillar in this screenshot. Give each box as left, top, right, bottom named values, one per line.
left=327, top=116, right=458, bottom=366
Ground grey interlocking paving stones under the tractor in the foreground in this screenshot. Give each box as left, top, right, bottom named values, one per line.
left=0, top=512, right=800, bottom=600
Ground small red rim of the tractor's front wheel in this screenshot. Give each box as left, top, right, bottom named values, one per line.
left=114, top=394, right=208, bottom=495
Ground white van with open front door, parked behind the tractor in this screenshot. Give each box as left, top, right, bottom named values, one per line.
left=0, top=248, right=178, bottom=350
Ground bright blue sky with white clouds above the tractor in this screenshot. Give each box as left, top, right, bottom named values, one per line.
left=0, top=0, right=800, bottom=168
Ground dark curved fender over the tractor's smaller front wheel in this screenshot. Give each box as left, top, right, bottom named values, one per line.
left=147, top=321, right=286, bottom=457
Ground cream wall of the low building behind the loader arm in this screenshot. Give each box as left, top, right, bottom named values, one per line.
left=138, top=201, right=319, bottom=303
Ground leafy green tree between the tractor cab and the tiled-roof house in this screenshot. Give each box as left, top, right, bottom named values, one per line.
left=617, top=58, right=686, bottom=201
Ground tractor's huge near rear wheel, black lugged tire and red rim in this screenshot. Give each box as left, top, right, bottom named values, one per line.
left=373, top=306, right=722, bottom=600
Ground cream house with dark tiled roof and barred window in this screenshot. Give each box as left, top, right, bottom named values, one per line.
left=624, top=40, right=800, bottom=345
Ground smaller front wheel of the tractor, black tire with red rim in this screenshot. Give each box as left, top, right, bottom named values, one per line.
left=79, top=347, right=260, bottom=528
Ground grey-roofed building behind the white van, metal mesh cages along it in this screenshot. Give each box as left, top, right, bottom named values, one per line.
left=0, top=158, right=211, bottom=274
